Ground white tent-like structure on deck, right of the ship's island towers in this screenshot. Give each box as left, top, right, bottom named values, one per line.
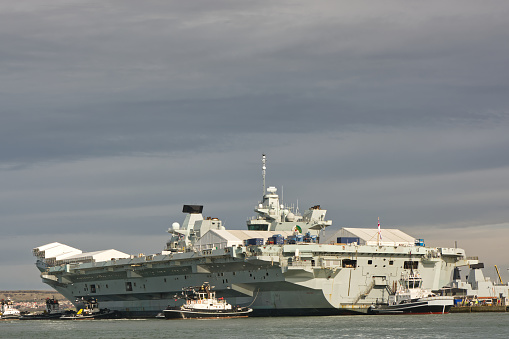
left=326, top=227, right=416, bottom=246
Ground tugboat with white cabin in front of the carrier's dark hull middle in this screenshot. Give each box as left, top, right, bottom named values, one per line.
left=163, top=283, right=253, bottom=319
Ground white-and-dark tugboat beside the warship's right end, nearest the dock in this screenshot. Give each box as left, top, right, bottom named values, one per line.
left=368, top=271, right=454, bottom=314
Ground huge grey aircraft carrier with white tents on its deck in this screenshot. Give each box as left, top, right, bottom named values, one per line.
left=33, top=155, right=475, bottom=317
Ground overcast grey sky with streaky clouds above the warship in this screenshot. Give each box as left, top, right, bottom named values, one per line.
left=0, top=0, right=509, bottom=290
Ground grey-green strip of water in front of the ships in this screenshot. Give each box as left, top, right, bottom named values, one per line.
left=0, top=313, right=509, bottom=339
